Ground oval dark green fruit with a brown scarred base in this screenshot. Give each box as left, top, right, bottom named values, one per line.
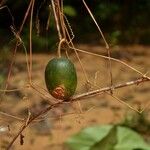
left=45, top=58, right=77, bottom=100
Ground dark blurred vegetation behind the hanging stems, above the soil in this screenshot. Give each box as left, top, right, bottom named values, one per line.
left=0, top=0, right=150, bottom=52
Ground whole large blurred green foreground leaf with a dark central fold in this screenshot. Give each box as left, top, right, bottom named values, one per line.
left=66, top=125, right=150, bottom=150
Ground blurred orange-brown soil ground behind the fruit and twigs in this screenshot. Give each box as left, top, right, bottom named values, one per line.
left=0, top=45, right=150, bottom=150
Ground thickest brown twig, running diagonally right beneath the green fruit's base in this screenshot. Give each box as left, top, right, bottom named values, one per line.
left=7, top=77, right=150, bottom=150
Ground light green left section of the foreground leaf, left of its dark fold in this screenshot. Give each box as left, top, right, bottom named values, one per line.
left=66, top=125, right=112, bottom=150
